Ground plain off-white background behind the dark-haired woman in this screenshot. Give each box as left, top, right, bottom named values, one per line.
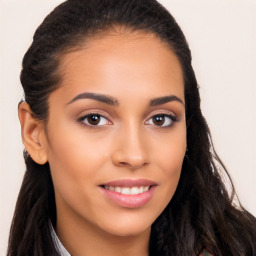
left=0, top=0, right=256, bottom=255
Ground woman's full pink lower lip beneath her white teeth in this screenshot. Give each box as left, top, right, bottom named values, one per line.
left=100, top=186, right=156, bottom=208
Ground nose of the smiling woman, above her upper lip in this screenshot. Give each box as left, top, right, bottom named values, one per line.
left=112, top=124, right=149, bottom=169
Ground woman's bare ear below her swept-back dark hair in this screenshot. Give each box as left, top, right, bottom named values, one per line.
left=18, top=102, right=47, bottom=164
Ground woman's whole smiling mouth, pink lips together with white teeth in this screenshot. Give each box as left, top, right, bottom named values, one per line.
left=100, top=179, right=157, bottom=208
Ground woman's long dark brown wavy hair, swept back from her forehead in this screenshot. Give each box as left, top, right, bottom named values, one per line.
left=7, top=0, right=256, bottom=256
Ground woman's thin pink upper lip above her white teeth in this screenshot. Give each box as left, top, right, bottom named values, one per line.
left=101, top=179, right=157, bottom=187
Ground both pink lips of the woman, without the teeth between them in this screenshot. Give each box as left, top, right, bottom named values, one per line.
left=100, top=179, right=157, bottom=208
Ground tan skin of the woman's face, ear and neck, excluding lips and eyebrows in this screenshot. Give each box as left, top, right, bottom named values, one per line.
left=19, top=32, right=186, bottom=256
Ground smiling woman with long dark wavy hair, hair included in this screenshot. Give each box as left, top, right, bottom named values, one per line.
left=8, top=0, right=256, bottom=256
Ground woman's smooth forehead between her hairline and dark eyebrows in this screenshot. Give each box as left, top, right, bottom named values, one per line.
left=54, top=32, right=184, bottom=103
